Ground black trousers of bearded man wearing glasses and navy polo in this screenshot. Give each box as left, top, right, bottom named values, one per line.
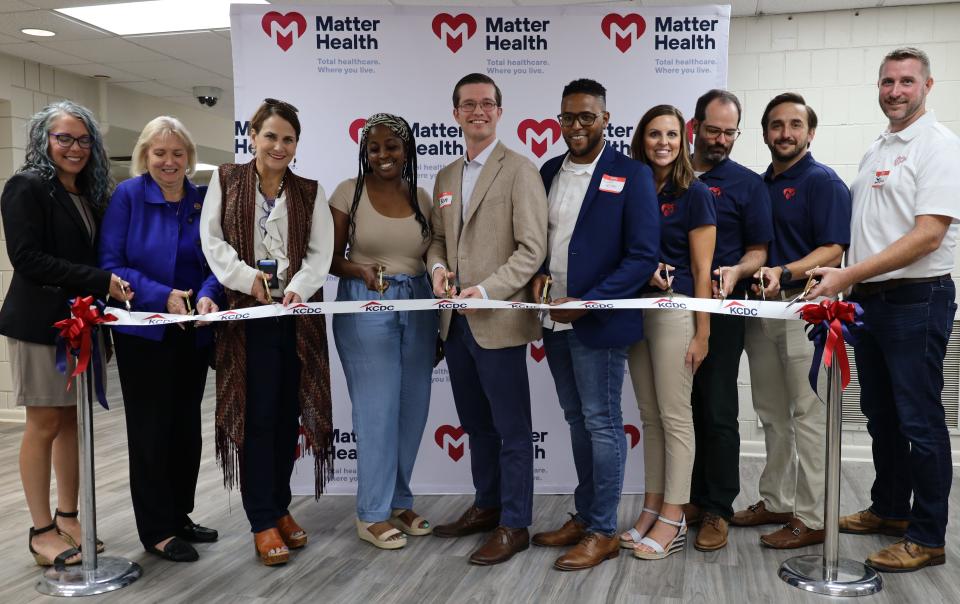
left=690, top=315, right=746, bottom=520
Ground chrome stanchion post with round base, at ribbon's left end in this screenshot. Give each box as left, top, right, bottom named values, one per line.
left=37, top=344, right=143, bottom=596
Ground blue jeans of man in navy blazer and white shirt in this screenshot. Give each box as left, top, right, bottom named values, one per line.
left=543, top=329, right=627, bottom=536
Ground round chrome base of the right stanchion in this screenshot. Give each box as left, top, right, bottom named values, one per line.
left=778, top=555, right=883, bottom=596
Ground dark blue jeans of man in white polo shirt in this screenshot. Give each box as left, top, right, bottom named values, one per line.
left=854, top=277, right=957, bottom=547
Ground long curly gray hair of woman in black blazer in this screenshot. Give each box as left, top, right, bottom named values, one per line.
left=17, top=100, right=114, bottom=214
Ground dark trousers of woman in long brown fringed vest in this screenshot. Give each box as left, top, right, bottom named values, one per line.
left=240, top=317, right=300, bottom=533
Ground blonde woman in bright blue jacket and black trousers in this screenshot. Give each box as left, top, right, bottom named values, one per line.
left=100, top=116, right=222, bottom=562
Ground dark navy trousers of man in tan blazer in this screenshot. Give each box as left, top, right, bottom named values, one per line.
left=446, top=313, right=533, bottom=528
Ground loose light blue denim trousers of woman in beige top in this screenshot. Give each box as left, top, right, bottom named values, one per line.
left=333, top=275, right=438, bottom=522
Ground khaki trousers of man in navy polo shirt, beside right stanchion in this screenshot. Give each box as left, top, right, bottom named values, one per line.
left=744, top=319, right=827, bottom=529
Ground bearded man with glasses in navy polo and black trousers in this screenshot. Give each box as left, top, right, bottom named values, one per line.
left=687, top=89, right=773, bottom=551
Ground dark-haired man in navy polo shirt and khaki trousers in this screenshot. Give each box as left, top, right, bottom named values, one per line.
left=732, top=92, right=851, bottom=549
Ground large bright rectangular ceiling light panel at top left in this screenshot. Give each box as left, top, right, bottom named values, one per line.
left=56, top=0, right=267, bottom=36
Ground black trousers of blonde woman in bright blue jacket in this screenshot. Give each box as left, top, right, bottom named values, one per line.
left=113, top=325, right=210, bottom=547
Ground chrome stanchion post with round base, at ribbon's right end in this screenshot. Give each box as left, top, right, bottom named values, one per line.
left=778, top=351, right=883, bottom=596
